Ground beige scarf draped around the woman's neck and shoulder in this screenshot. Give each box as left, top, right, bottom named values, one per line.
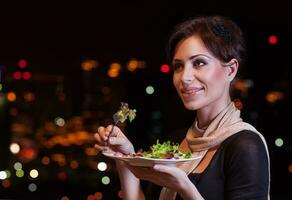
left=159, top=102, right=270, bottom=200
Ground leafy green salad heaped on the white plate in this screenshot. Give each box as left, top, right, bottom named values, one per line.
left=133, top=140, right=192, bottom=159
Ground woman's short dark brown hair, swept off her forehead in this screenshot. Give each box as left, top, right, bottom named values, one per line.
left=167, top=16, right=246, bottom=64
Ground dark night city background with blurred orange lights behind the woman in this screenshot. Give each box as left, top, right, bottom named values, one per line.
left=0, top=0, right=292, bottom=200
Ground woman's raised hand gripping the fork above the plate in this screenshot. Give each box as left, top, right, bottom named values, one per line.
left=94, top=125, right=135, bottom=155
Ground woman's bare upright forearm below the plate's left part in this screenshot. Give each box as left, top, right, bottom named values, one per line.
left=116, top=160, right=145, bottom=200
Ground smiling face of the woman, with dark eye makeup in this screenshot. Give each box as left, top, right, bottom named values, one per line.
left=172, top=36, right=231, bottom=110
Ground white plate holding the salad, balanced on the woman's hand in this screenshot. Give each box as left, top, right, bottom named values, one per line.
left=102, top=152, right=201, bottom=167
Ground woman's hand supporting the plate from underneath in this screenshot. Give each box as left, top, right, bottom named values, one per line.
left=127, top=164, right=189, bottom=192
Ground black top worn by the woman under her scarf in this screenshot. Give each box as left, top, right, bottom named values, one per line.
left=176, top=130, right=269, bottom=200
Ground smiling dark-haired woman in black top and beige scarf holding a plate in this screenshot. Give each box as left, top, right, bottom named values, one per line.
left=95, top=16, right=270, bottom=200
